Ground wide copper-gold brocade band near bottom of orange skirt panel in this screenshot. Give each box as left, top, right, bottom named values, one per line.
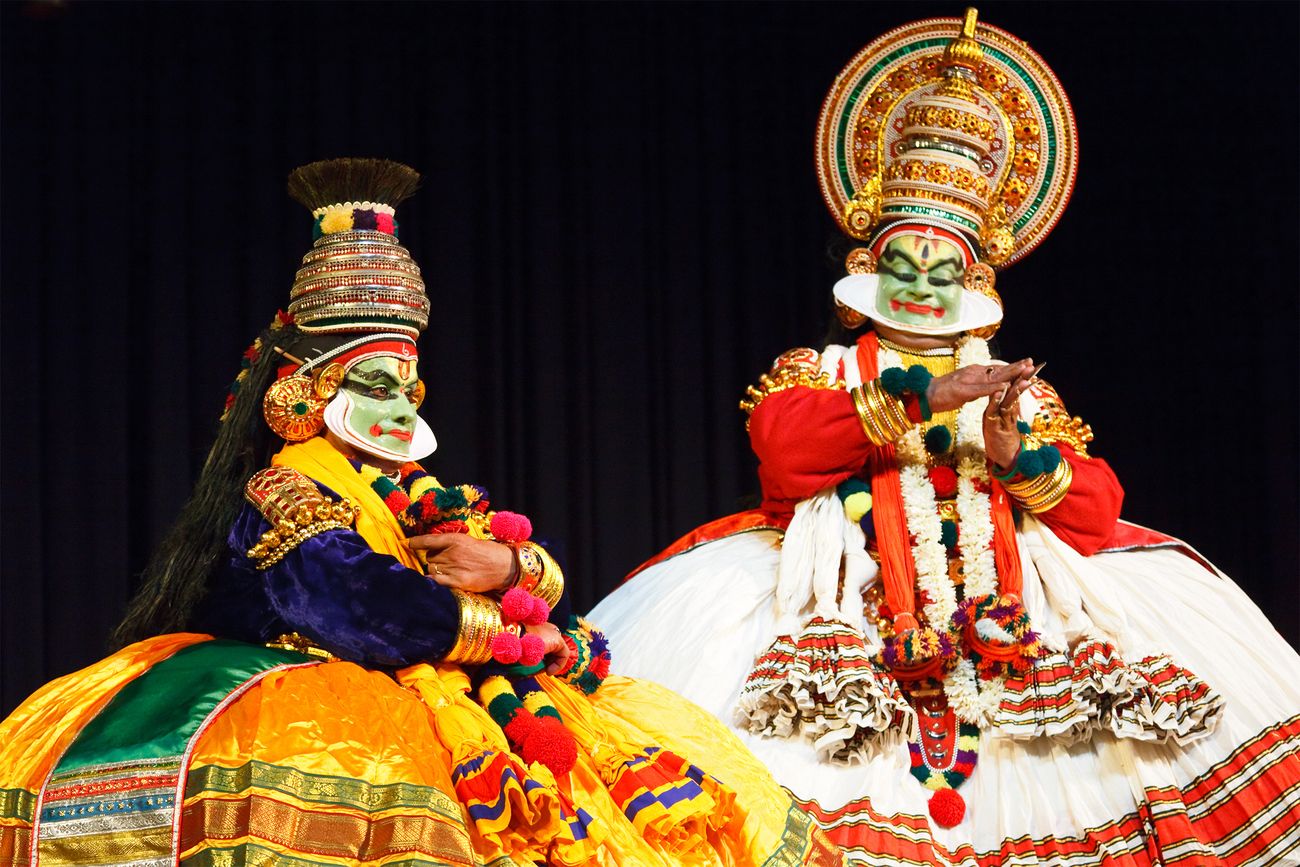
left=181, top=792, right=475, bottom=864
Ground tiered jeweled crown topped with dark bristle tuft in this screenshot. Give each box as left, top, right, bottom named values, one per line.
left=289, top=159, right=429, bottom=337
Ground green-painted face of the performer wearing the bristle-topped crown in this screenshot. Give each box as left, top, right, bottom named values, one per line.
left=343, top=356, right=419, bottom=454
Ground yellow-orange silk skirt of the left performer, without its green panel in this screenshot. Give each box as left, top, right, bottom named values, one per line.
left=0, top=634, right=840, bottom=867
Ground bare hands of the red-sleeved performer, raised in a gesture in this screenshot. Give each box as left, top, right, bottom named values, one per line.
left=926, top=359, right=1035, bottom=468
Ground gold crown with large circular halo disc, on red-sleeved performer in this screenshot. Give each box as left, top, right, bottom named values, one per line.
left=816, top=9, right=1079, bottom=269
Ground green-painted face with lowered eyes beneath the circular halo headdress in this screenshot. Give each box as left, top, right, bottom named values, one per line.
left=876, top=235, right=963, bottom=328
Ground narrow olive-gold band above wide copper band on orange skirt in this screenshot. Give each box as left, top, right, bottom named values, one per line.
left=185, top=762, right=463, bottom=823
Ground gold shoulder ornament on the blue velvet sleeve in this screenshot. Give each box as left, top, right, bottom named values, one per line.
left=244, top=467, right=359, bottom=569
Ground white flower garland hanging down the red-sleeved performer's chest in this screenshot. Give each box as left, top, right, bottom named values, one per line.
left=876, top=337, right=1006, bottom=725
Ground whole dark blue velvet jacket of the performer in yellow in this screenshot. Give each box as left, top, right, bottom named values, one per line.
left=192, top=485, right=571, bottom=668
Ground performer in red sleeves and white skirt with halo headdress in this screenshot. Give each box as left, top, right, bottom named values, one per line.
left=592, top=10, right=1300, bottom=866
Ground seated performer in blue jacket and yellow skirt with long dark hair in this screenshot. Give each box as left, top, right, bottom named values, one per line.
left=0, top=160, right=841, bottom=867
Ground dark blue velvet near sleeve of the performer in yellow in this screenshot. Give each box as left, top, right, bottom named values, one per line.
left=228, top=507, right=460, bottom=666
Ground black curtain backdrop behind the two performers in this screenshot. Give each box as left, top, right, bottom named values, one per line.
left=0, top=0, right=1300, bottom=712
